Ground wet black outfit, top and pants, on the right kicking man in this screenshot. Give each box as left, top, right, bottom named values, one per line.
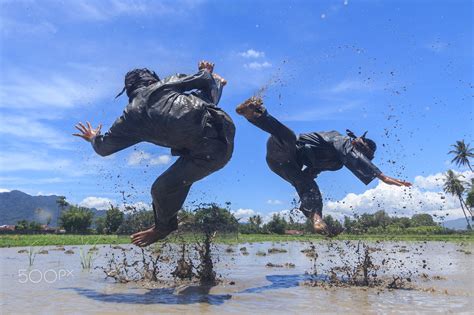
left=250, top=112, right=381, bottom=216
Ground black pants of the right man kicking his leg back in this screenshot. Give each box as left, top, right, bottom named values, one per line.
left=250, top=112, right=323, bottom=217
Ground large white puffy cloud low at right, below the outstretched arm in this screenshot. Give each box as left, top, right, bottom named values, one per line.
left=325, top=172, right=472, bottom=219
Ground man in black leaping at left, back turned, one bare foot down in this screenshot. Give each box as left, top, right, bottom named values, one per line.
left=74, top=61, right=235, bottom=246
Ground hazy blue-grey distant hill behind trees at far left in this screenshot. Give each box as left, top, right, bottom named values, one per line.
left=0, top=190, right=105, bottom=226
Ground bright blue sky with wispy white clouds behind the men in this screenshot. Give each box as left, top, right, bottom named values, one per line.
left=0, top=0, right=473, bottom=222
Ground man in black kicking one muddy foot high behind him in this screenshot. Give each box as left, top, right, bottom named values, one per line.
left=236, top=97, right=411, bottom=235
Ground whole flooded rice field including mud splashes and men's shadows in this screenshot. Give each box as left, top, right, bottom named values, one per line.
left=0, top=241, right=474, bottom=314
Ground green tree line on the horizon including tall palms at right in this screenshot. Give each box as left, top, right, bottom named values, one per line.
left=16, top=140, right=474, bottom=234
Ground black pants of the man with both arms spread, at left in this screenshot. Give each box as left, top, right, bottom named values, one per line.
left=151, top=108, right=235, bottom=230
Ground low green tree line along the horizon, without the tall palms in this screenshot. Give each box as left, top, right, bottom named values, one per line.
left=18, top=204, right=466, bottom=235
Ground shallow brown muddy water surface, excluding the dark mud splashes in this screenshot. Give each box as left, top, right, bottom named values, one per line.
left=0, top=242, right=474, bottom=314
